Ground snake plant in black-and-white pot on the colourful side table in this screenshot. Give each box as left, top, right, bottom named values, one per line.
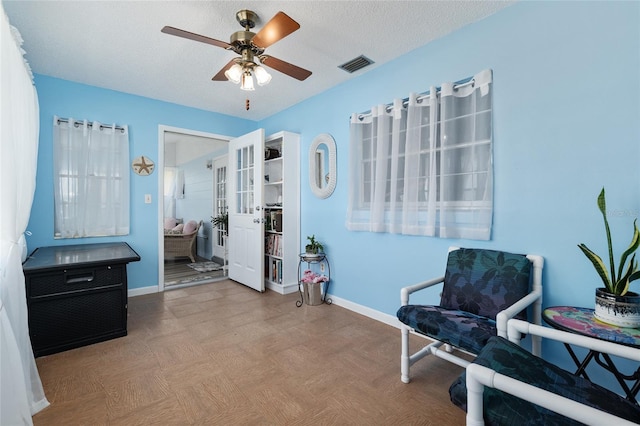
left=578, top=188, right=640, bottom=328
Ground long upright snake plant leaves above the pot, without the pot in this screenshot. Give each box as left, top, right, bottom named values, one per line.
left=578, top=188, right=640, bottom=296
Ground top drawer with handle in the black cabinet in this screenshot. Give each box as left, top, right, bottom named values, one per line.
left=26, top=265, right=126, bottom=298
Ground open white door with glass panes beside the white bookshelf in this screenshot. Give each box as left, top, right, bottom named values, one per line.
left=227, top=129, right=264, bottom=292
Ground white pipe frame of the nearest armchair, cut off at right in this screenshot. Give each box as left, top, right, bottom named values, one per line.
left=466, top=319, right=640, bottom=426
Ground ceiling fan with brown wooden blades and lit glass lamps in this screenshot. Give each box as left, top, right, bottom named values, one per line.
left=162, top=10, right=311, bottom=90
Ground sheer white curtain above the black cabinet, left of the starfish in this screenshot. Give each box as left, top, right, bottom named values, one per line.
left=53, top=117, right=130, bottom=238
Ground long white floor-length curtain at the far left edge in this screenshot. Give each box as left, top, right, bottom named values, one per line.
left=0, top=3, right=49, bottom=425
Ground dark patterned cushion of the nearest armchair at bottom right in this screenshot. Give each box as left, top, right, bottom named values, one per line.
left=449, top=336, right=640, bottom=426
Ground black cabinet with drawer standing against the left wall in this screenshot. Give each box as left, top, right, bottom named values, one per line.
left=22, top=243, right=140, bottom=357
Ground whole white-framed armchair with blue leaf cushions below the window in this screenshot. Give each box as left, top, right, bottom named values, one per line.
left=397, top=247, right=544, bottom=383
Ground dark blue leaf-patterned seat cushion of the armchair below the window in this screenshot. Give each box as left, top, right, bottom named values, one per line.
left=397, top=305, right=497, bottom=354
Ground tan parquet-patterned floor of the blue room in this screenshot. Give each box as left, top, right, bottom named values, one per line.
left=33, top=280, right=465, bottom=426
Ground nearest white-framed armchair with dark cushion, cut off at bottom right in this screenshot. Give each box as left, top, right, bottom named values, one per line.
left=449, top=319, right=640, bottom=426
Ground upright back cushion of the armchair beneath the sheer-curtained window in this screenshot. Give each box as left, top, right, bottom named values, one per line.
left=440, top=248, right=531, bottom=320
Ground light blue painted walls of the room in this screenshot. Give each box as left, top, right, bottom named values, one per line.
left=29, top=2, right=640, bottom=396
